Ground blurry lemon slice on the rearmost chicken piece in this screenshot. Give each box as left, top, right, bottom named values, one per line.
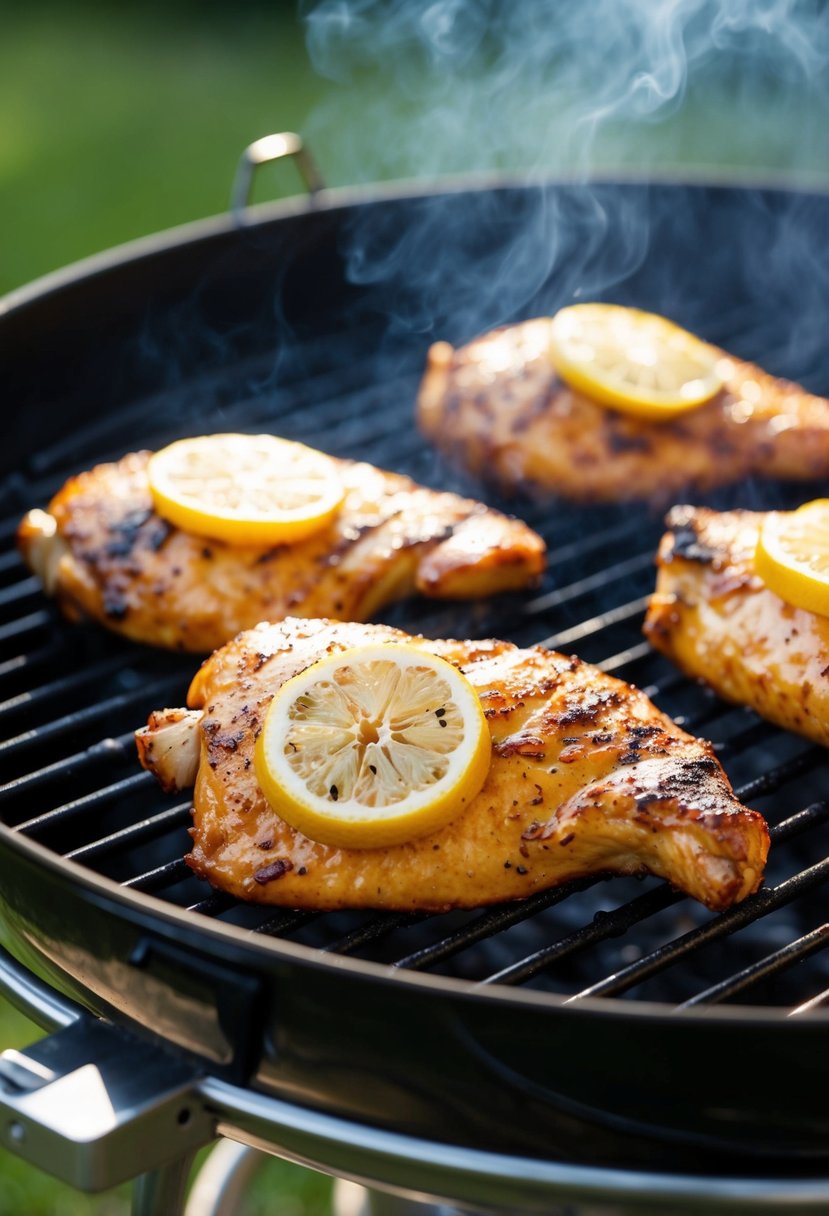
left=549, top=304, right=722, bottom=421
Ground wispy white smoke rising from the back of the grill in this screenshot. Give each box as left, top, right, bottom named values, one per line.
left=294, top=0, right=829, bottom=359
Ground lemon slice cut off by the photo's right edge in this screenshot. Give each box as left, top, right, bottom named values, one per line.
left=755, top=499, right=829, bottom=617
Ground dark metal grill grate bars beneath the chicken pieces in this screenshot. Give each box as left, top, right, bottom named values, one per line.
left=0, top=336, right=829, bottom=1008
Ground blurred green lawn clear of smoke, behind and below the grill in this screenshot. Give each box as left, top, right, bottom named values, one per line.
left=0, top=0, right=329, bottom=1216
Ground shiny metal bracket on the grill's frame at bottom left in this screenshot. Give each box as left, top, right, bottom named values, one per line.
left=0, top=1015, right=215, bottom=1190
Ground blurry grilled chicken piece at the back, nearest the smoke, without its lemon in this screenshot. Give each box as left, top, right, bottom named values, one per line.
left=417, top=317, right=829, bottom=502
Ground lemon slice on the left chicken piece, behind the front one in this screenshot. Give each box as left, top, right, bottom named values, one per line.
left=147, top=434, right=345, bottom=545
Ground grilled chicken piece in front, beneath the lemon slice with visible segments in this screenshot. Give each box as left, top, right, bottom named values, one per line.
left=136, top=619, right=768, bottom=911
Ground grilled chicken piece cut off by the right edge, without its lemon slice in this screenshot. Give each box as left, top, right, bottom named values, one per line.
left=644, top=506, right=829, bottom=744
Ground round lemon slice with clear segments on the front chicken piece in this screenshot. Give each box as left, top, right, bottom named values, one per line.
left=255, top=642, right=491, bottom=849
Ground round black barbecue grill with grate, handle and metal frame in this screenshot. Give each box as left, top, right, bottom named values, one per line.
left=0, top=137, right=829, bottom=1216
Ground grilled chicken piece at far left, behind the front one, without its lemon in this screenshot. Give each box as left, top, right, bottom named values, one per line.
left=18, top=452, right=545, bottom=653
